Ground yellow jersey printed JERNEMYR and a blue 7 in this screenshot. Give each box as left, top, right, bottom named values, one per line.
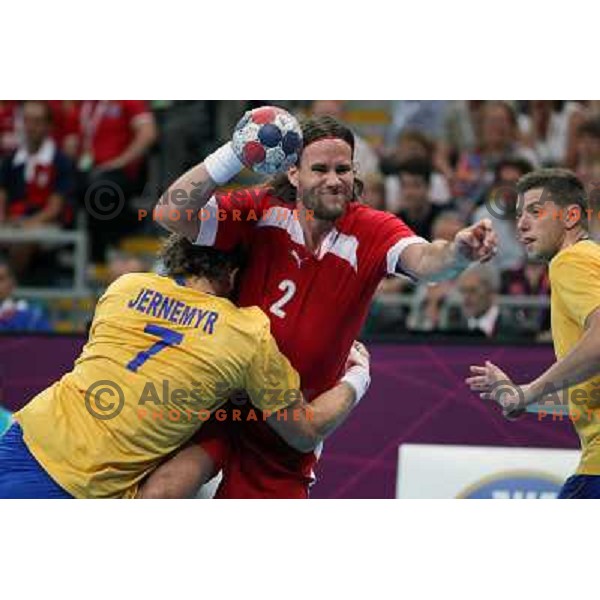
left=0, top=273, right=300, bottom=498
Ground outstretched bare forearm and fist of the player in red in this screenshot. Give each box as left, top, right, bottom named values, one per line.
left=398, top=219, right=498, bottom=281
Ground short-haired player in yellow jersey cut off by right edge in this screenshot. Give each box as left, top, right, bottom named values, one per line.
left=467, top=169, right=600, bottom=498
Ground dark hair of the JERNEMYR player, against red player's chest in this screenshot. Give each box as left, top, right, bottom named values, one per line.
left=158, top=233, right=242, bottom=281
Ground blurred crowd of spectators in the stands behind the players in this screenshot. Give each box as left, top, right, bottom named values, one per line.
left=0, top=100, right=600, bottom=339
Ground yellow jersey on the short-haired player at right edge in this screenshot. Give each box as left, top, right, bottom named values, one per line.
left=549, top=240, right=600, bottom=475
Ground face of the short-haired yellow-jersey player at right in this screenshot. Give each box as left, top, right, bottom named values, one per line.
left=517, top=188, right=566, bottom=260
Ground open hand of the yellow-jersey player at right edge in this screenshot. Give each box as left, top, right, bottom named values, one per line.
left=465, top=361, right=528, bottom=421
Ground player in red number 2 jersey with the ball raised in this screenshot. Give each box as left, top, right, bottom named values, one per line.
left=142, top=107, right=496, bottom=498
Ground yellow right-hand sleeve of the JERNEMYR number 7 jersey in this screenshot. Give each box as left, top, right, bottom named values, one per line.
left=245, top=317, right=302, bottom=412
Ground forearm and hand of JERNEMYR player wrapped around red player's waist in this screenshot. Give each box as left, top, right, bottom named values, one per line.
left=267, top=342, right=371, bottom=452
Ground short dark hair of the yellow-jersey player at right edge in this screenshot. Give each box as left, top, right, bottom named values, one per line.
left=517, top=168, right=588, bottom=226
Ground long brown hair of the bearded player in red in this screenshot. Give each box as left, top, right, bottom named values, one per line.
left=265, top=115, right=364, bottom=202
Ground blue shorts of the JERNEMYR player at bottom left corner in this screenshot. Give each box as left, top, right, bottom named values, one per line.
left=0, top=423, right=73, bottom=498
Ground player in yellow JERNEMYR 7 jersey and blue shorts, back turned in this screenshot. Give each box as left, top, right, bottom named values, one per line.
left=0, top=235, right=370, bottom=498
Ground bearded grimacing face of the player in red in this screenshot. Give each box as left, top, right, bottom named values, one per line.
left=288, top=138, right=354, bottom=221
